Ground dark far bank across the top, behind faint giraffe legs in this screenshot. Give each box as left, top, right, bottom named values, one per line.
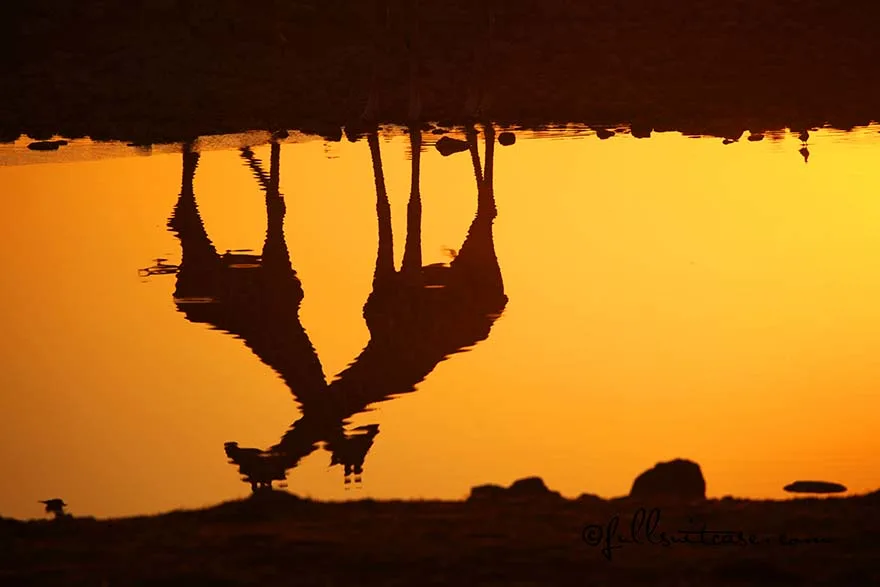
left=0, top=0, right=880, bottom=142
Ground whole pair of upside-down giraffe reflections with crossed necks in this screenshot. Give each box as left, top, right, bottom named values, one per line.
left=162, top=125, right=507, bottom=492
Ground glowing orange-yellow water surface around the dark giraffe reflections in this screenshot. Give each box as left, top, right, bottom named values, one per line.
left=0, top=124, right=880, bottom=517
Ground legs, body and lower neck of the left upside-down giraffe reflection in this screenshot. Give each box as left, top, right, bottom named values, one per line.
left=168, top=142, right=326, bottom=408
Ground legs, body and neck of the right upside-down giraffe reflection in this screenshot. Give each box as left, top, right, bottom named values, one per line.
left=272, top=127, right=507, bottom=486
